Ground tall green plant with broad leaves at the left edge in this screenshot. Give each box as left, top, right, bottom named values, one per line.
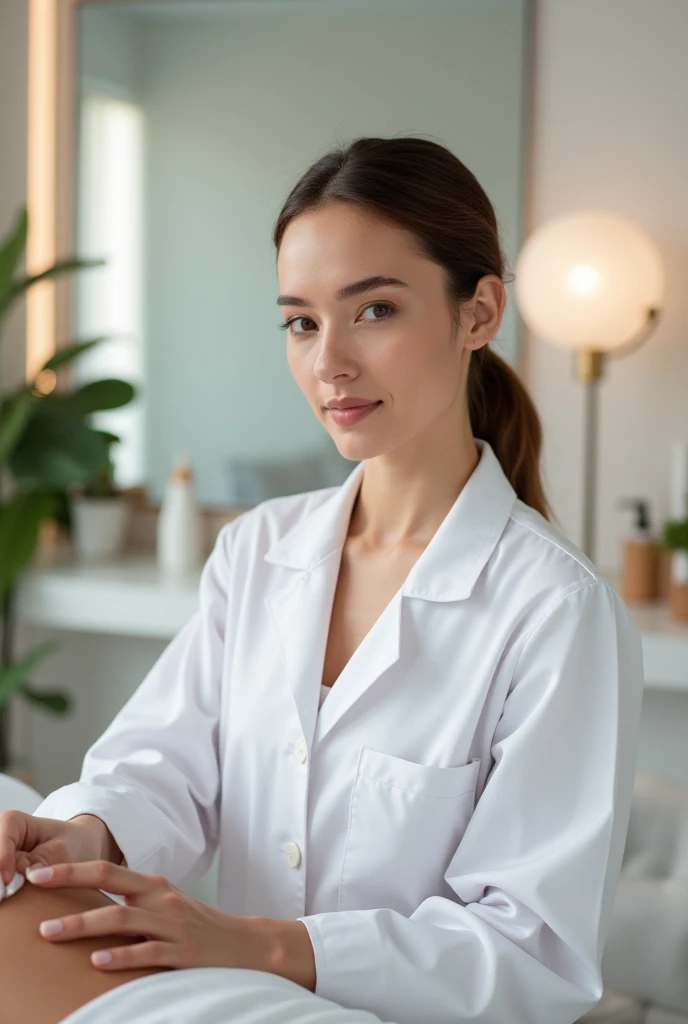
left=0, top=208, right=134, bottom=771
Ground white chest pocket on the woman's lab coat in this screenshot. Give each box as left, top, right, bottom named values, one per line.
left=339, top=746, right=480, bottom=915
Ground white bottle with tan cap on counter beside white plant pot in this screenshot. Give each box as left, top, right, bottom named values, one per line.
left=157, top=453, right=202, bottom=573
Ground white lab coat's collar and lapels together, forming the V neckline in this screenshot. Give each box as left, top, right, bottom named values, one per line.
left=265, top=438, right=516, bottom=742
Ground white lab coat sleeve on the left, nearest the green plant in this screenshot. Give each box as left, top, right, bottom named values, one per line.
left=34, top=519, right=238, bottom=884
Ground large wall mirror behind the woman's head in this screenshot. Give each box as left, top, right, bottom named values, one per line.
left=40, top=0, right=529, bottom=506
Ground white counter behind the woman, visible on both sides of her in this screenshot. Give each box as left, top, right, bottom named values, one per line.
left=17, top=551, right=688, bottom=692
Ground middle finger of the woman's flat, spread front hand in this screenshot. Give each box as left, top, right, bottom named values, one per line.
left=38, top=903, right=178, bottom=942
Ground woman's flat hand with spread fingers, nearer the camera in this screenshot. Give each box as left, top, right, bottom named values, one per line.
left=27, top=860, right=268, bottom=971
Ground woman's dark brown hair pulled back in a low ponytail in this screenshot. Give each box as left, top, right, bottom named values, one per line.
left=273, top=136, right=552, bottom=519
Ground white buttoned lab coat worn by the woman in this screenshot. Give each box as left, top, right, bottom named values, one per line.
left=35, top=438, right=643, bottom=1024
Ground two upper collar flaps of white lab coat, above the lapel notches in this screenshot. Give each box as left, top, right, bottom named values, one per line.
left=265, top=437, right=516, bottom=601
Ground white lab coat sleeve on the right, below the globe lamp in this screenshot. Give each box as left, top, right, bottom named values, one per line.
left=298, top=578, right=643, bottom=1024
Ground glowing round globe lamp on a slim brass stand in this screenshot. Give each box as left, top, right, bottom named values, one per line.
left=514, top=209, right=664, bottom=560
